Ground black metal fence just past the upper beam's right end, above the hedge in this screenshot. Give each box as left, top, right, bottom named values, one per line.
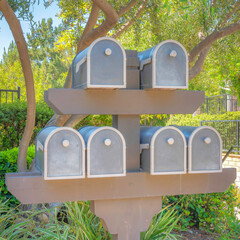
left=201, top=94, right=240, bottom=114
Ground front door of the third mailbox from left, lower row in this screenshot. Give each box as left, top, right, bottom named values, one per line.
left=151, top=127, right=186, bottom=174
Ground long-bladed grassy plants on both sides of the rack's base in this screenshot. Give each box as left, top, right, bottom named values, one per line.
left=0, top=202, right=179, bottom=240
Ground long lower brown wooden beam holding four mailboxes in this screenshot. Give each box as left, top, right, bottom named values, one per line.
left=6, top=168, right=236, bottom=204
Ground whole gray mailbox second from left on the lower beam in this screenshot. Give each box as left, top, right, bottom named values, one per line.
left=79, top=126, right=126, bottom=178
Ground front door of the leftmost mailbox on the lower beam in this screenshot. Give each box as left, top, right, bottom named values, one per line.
left=45, top=128, right=85, bottom=179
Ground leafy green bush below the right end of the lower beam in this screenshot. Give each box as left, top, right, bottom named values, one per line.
left=164, top=185, right=240, bottom=237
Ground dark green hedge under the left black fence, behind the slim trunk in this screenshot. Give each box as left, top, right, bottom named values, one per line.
left=0, top=101, right=53, bottom=151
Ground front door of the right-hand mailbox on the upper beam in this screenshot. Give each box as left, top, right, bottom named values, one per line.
left=152, top=41, right=188, bottom=88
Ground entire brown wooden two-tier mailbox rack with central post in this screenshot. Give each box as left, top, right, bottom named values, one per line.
left=6, top=51, right=236, bottom=240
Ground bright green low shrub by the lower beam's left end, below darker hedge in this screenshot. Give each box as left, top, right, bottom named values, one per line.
left=0, top=146, right=35, bottom=206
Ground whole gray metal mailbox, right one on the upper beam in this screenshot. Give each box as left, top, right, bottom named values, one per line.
left=138, top=40, right=188, bottom=89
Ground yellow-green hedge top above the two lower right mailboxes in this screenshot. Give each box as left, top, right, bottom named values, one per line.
left=167, top=112, right=240, bottom=126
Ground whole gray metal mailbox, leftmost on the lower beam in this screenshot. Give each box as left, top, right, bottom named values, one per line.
left=35, top=127, right=85, bottom=180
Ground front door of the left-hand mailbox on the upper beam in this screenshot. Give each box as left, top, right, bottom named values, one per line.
left=88, top=38, right=126, bottom=88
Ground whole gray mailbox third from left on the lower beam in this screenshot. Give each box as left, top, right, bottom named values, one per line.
left=140, top=126, right=187, bottom=175
